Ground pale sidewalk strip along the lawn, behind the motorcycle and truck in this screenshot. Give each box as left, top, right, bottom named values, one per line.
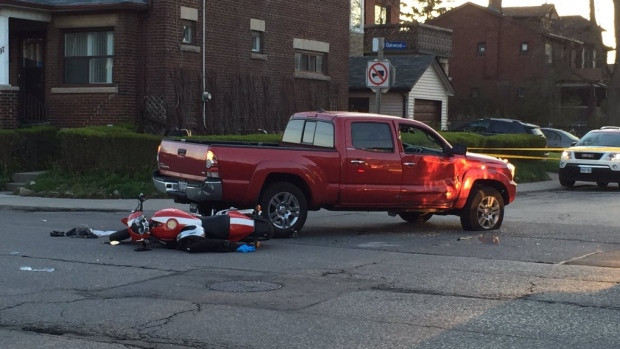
left=0, top=173, right=562, bottom=212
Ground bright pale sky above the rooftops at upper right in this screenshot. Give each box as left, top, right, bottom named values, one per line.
left=443, top=0, right=616, bottom=63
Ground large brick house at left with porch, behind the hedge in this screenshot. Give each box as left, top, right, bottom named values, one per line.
left=0, top=0, right=350, bottom=133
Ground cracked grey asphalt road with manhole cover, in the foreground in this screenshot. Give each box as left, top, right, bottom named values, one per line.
left=0, top=186, right=620, bottom=348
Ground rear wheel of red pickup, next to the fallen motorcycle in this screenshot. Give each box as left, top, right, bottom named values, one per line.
left=259, top=182, right=308, bottom=238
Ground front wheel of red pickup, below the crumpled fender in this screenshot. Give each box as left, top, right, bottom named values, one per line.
left=461, top=186, right=504, bottom=230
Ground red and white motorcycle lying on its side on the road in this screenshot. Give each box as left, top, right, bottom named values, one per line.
left=109, top=194, right=273, bottom=252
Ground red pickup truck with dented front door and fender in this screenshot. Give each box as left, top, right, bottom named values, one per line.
left=153, top=112, right=517, bottom=237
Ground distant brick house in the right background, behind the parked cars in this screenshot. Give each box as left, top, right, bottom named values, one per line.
left=427, top=0, right=609, bottom=129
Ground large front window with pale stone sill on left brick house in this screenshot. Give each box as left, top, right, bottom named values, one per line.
left=64, top=31, right=114, bottom=84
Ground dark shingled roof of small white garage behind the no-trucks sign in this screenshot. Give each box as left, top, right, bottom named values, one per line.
left=349, top=55, right=453, bottom=91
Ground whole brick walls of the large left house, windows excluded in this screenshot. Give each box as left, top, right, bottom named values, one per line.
left=11, top=0, right=350, bottom=133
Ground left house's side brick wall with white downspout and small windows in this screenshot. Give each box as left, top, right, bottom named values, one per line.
left=145, top=0, right=350, bottom=133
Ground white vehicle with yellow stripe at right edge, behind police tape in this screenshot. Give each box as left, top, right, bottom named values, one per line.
left=559, top=127, right=620, bottom=188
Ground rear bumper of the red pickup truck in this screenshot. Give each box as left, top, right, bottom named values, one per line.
left=153, top=171, right=222, bottom=202
